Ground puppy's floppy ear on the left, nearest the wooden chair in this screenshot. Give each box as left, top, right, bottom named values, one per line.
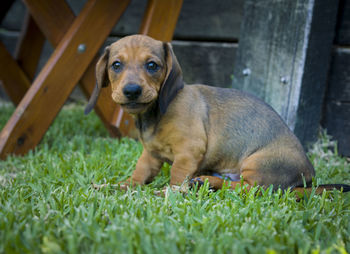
left=84, top=47, right=109, bottom=114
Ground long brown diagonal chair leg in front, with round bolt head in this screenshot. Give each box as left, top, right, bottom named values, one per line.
left=0, top=0, right=128, bottom=159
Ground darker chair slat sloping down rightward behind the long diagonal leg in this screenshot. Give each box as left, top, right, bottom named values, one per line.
left=25, top=0, right=129, bottom=137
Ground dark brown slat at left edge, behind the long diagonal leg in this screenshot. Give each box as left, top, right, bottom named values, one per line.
left=0, top=42, right=30, bottom=105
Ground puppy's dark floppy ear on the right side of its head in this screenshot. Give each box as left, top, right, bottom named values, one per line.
left=158, top=42, right=184, bottom=115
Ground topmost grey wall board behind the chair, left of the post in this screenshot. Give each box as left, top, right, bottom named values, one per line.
left=3, top=0, right=244, bottom=41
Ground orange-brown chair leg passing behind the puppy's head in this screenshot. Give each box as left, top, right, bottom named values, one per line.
left=111, top=0, right=182, bottom=137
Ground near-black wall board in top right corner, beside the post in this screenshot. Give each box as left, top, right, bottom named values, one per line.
left=335, top=0, right=350, bottom=45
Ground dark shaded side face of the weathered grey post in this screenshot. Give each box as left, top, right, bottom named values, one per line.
left=294, top=0, right=339, bottom=144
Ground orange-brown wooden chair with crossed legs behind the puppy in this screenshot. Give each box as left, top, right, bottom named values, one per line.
left=0, top=0, right=182, bottom=159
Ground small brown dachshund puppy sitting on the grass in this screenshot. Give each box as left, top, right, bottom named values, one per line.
left=86, top=35, right=348, bottom=192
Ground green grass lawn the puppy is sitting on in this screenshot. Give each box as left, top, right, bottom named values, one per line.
left=0, top=106, right=350, bottom=254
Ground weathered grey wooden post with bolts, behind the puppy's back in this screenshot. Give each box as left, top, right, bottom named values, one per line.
left=233, top=0, right=338, bottom=144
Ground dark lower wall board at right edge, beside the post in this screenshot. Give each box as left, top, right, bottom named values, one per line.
left=322, top=48, right=350, bottom=156
